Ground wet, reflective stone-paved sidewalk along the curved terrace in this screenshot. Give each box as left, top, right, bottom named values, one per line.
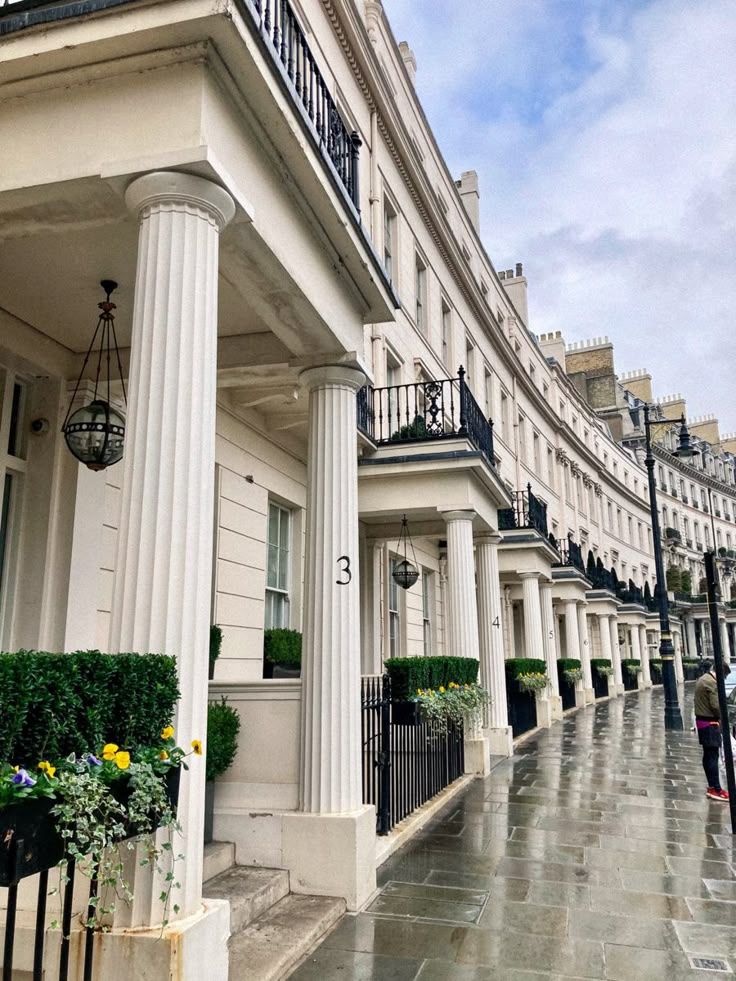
left=292, top=686, right=736, bottom=981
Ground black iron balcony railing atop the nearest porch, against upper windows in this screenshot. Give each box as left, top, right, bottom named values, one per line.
left=253, top=0, right=361, bottom=211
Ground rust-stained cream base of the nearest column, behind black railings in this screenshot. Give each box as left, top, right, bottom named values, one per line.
left=33, top=899, right=230, bottom=981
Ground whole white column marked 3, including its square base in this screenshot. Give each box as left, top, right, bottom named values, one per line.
left=282, top=365, right=375, bottom=909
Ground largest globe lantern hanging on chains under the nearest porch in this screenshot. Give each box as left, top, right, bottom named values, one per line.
left=61, top=279, right=127, bottom=470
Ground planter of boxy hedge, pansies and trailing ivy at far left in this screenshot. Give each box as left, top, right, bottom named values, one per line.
left=0, top=651, right=202, bottom=927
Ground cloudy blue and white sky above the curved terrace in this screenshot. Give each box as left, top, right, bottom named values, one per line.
left=384, top=0, right=736, bottom=433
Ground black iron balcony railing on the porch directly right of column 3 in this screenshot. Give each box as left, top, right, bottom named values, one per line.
left=357, top=367, right=496, bottom=467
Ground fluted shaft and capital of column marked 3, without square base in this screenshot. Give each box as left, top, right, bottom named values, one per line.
left=301, top=366, right=365, bottom=814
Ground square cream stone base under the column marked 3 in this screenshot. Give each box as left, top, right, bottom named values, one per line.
left=280, top=804, right=376, bottom=912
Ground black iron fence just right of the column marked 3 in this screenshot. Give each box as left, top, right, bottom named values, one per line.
left=361, top=675, right=465, bottom=835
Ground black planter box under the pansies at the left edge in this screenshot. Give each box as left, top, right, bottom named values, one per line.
left=0, top=797, right=64, bottom=887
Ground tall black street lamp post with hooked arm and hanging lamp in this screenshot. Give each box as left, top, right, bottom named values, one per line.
left=644, top=403, right=699, bottom=730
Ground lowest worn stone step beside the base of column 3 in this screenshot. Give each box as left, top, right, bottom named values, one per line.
left=229, top=894, right=345, bottom=981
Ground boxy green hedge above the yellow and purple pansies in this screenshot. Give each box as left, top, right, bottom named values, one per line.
left=0, top=651, right=179, bottom=769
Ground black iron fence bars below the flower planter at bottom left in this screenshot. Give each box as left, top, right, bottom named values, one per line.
left=2, top=848, right=97, bottom=981
